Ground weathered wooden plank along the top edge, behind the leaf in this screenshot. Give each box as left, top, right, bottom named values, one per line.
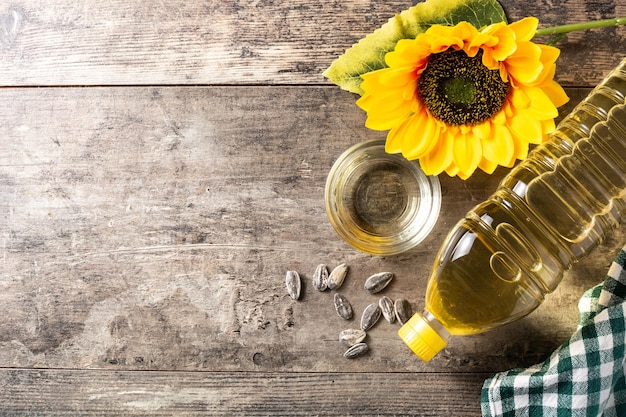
left=0, top=0, right=626, bottom=86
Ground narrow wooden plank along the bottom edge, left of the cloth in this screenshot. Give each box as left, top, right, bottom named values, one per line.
left=0, top=370, right=487, bottom=417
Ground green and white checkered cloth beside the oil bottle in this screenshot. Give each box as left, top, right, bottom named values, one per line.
left=481, top=246, right=626, bottom=417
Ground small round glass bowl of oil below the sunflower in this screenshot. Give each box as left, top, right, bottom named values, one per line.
left=324, top=139, right=441, bottom=256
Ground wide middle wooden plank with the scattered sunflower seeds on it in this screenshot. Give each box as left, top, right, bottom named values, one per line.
left=0, top=83, right=626, bottom=372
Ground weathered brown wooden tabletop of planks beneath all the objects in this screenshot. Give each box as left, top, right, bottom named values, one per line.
left=0, top=0, right=626, bottom=416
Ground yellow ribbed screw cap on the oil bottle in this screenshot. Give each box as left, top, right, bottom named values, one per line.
left=398, top=313, right=448, bottom=362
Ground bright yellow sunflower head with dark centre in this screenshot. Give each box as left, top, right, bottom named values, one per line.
left=357, top=17, right=568, bottom=179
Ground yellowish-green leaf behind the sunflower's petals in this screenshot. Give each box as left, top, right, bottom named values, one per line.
left=324, top=0, right=506, bottom=94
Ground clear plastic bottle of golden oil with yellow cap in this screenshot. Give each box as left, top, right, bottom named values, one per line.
left=398, top=59, right=626, bottom=361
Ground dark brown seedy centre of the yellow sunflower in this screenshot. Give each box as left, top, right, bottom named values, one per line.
left=417, top=49, right=509, bottom=125
